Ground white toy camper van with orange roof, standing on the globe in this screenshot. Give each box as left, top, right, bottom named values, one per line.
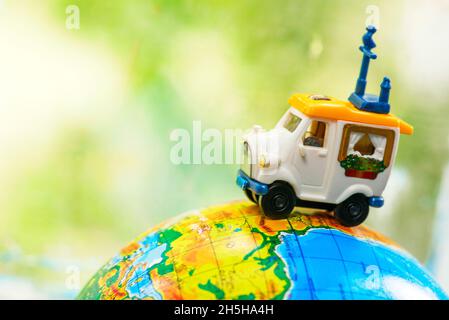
left=237, top=26, right=413, bottom=226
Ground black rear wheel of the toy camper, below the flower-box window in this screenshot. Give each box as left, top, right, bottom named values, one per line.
left=335, top=193, right=369, bottom=227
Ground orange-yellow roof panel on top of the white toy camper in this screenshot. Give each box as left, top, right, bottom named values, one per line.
left=288, top=94, right=413, bottom=134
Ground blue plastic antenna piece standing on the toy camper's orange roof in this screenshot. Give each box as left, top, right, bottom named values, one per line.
left=348, top=25, right=391, bottom=113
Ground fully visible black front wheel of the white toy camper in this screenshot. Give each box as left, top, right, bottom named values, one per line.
left=259, top=182, right=296, bottom=219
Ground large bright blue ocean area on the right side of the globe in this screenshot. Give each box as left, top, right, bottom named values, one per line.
left=277, top=229, right=448, bottom=300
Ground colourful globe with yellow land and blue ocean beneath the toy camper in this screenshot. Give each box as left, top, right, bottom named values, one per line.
left=79, top=202, right=447, bottom=300
